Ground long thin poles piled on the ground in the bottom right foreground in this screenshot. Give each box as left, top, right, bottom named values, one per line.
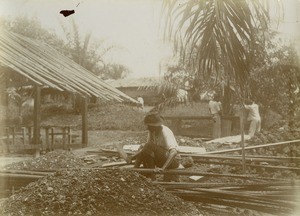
left=132, top=169, right=300, bottom=215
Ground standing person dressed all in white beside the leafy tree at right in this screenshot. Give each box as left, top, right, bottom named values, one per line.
left=244, top=100, right=261, bottom=137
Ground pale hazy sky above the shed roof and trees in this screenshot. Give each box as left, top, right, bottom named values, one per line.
left=0, top=0, right=300, bottom=77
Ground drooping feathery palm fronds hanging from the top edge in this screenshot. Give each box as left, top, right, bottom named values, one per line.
left=163, top=0, right=280, bottom=99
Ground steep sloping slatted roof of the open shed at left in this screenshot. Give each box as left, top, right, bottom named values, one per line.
left=0, top=29, right=136, bottom=102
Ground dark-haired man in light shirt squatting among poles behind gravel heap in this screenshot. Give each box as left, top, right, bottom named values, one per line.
left=127, top=113, right=180, bottom=181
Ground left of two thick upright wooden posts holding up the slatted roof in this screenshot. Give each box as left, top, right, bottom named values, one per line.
left=33, top=85, right=41, bottom=145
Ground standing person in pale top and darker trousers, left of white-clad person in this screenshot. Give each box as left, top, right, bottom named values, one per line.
left=208, top=95, right=222, bottom=139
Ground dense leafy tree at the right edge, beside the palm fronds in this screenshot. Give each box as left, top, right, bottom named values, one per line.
left=250, top=34, right=300, bottom=117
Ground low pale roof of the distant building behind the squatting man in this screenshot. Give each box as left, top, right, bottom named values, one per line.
left=106, top=77, right=161, bottom=88
